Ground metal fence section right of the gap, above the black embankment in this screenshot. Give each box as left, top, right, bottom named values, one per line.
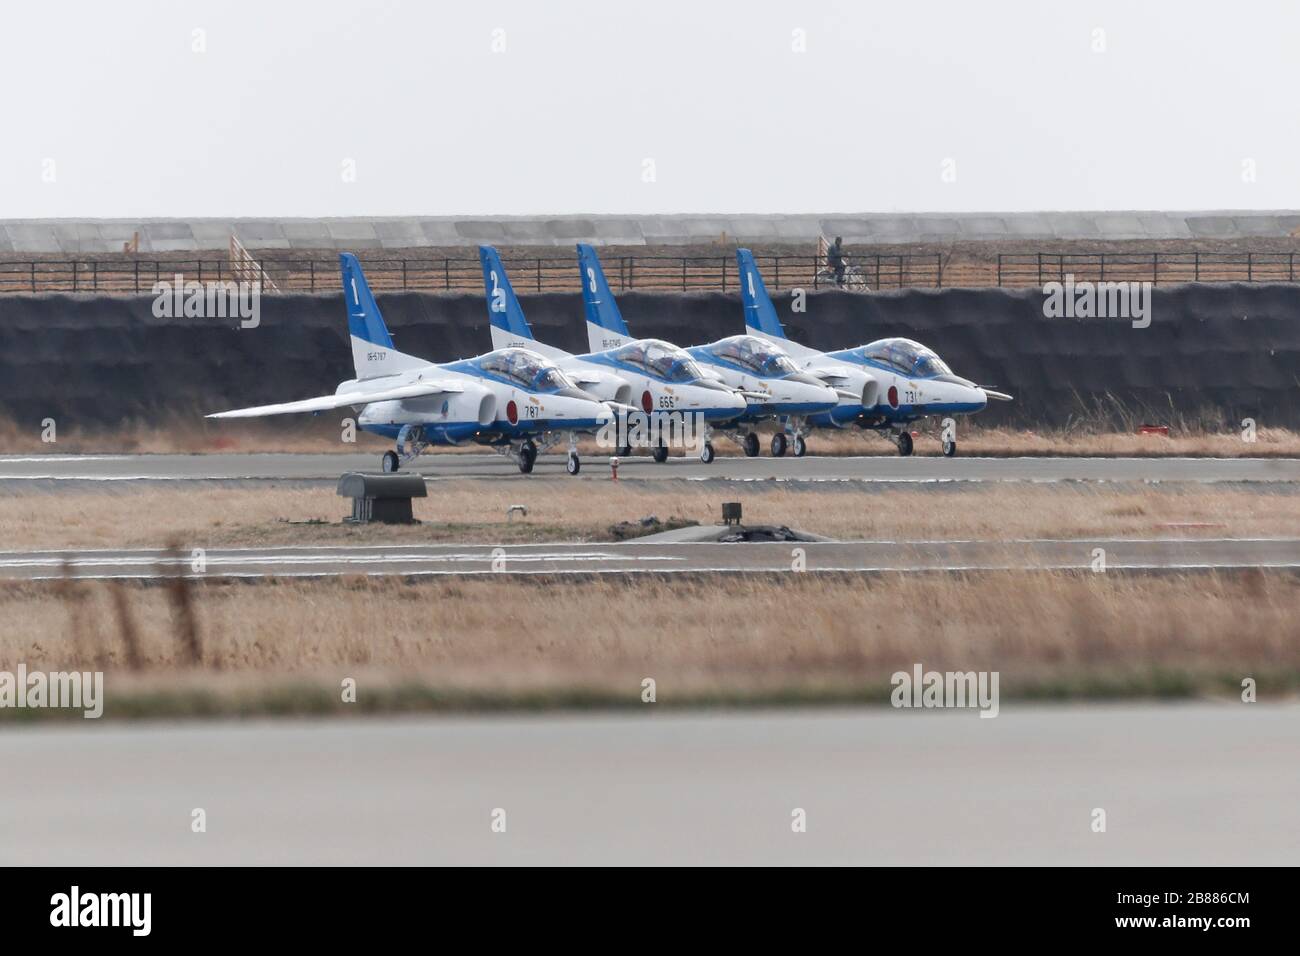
left=997, top=252, right=1296, bottom=287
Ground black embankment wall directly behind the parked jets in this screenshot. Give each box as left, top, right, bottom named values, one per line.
left=0, top=284, right=1300, bottom=428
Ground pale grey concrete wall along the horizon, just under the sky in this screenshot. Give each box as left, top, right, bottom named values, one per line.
left=0, top=209, right=1300, bottom=255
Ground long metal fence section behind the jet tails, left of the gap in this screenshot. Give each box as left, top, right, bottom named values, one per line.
left=0, top=254, right=944, bottom=294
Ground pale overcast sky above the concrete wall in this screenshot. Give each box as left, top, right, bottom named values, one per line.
left=0, top=0, right=1300, bottom=219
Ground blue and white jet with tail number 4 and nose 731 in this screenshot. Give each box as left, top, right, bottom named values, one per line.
left=736, top=248, right=1011, bottom=458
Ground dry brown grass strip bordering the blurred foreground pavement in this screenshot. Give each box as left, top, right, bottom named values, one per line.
left=0, top=572, right=1300, bottom=713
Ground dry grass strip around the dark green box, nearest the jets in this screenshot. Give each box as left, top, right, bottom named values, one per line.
left=0, top=476, right=1300, bottom=550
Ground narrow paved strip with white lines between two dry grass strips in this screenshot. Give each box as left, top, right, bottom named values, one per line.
left=0, top=538, right=1300, bottom=580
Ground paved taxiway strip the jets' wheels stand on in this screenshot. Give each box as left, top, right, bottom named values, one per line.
left=0, top=454, right=1300, bottom=483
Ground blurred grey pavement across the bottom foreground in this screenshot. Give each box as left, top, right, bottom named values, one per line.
left=0, top=702, right=1300, bottom=866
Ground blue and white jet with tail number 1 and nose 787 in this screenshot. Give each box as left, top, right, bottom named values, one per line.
left=208, top=252, right=614, bottom=475
